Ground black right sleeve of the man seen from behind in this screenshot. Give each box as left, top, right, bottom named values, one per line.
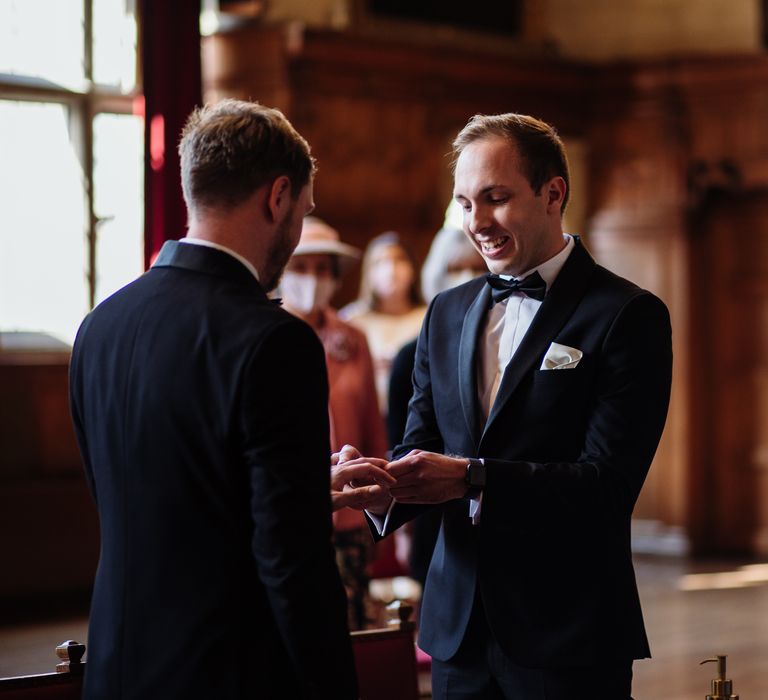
left=240, top=320, right=357, bottom=698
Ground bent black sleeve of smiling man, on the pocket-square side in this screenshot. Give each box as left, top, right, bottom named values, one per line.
left=483, top=293, right=672, bottom=522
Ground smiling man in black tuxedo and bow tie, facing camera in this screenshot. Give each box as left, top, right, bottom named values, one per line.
left=352, top=114, right=672, bottom=700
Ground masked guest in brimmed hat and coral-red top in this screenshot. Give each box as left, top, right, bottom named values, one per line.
left=280, top=216, right=387, bottom=629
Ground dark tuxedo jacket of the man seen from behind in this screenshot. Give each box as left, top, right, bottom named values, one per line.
left=70, top=242, right=357, bottom=700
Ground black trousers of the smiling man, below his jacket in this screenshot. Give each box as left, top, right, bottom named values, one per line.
left=432, top=601, right=632, bottom=700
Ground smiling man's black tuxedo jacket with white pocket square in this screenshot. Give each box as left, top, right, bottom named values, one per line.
left=384, top=240, right=672, bottom=668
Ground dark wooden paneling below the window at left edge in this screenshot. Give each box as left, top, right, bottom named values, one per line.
left=0, top=352, right=99, bottom=600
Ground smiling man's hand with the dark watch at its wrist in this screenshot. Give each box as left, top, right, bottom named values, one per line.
left=387, top=450, right=467, bottom=503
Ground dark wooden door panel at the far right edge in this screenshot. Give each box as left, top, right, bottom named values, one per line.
left=690, top=192, right=768, bottom=553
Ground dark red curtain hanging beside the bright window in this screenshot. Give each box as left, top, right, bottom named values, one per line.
left=139, top=0, right=202, bottom=267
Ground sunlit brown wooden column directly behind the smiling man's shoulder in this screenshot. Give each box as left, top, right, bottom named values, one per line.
left=587, top=67, right=688, bottom=535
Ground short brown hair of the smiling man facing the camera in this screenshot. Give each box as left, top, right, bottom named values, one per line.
left=453, top=112, right=571, bottom=212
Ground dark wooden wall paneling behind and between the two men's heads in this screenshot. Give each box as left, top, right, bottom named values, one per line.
left=204, top=26, right=590, bottom=301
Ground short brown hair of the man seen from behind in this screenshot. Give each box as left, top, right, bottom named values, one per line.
left=179, top=99, right=315, bottom=212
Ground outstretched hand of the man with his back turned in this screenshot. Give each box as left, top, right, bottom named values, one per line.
left=331, top=445, right=395, bottom=513
